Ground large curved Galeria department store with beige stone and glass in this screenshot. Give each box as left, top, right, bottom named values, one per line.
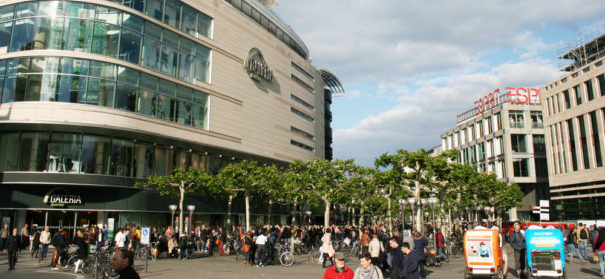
left=0, top=0, right=343, bottom=234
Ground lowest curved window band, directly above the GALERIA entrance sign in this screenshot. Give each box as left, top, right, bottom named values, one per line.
left=0, top=132, right=221, bottom=178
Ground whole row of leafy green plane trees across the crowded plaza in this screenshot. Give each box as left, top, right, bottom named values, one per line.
left=135, top=149, right=523, bottom=236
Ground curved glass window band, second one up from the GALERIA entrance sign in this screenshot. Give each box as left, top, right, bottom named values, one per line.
left=0, top=57, right=208, bottom=130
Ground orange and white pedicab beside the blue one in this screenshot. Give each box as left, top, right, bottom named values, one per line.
left=464, top=227, right=508, bottom=279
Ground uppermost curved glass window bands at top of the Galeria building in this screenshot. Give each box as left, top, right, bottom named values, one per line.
left=0, top=0, right=212, bottom=83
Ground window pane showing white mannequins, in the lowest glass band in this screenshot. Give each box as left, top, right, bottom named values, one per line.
left=46, top=133, right=82, bottom=173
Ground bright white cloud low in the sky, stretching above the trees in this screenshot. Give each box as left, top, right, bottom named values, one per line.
left=333, top=60, right=558, bottom=165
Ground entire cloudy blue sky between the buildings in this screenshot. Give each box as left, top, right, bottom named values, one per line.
left=273, top=0, right=605, bottom=165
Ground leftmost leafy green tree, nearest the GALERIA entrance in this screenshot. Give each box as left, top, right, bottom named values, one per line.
left=135, top=168, right=210, bottom=234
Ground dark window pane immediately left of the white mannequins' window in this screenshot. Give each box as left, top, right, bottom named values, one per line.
left=19, top=133, right=49, bottom=171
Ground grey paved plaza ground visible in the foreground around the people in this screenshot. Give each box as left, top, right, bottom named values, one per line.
left=0, top=247, right=600, bottom=279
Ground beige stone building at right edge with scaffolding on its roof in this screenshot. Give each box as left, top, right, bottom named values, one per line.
left=541, top=34, right=605, bottom=220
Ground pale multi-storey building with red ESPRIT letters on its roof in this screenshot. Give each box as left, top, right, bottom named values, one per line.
left=441, top=87, right=548, bottom=220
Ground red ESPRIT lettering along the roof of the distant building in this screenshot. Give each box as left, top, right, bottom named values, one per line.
left=474, top=87, right=540, bottom=115
